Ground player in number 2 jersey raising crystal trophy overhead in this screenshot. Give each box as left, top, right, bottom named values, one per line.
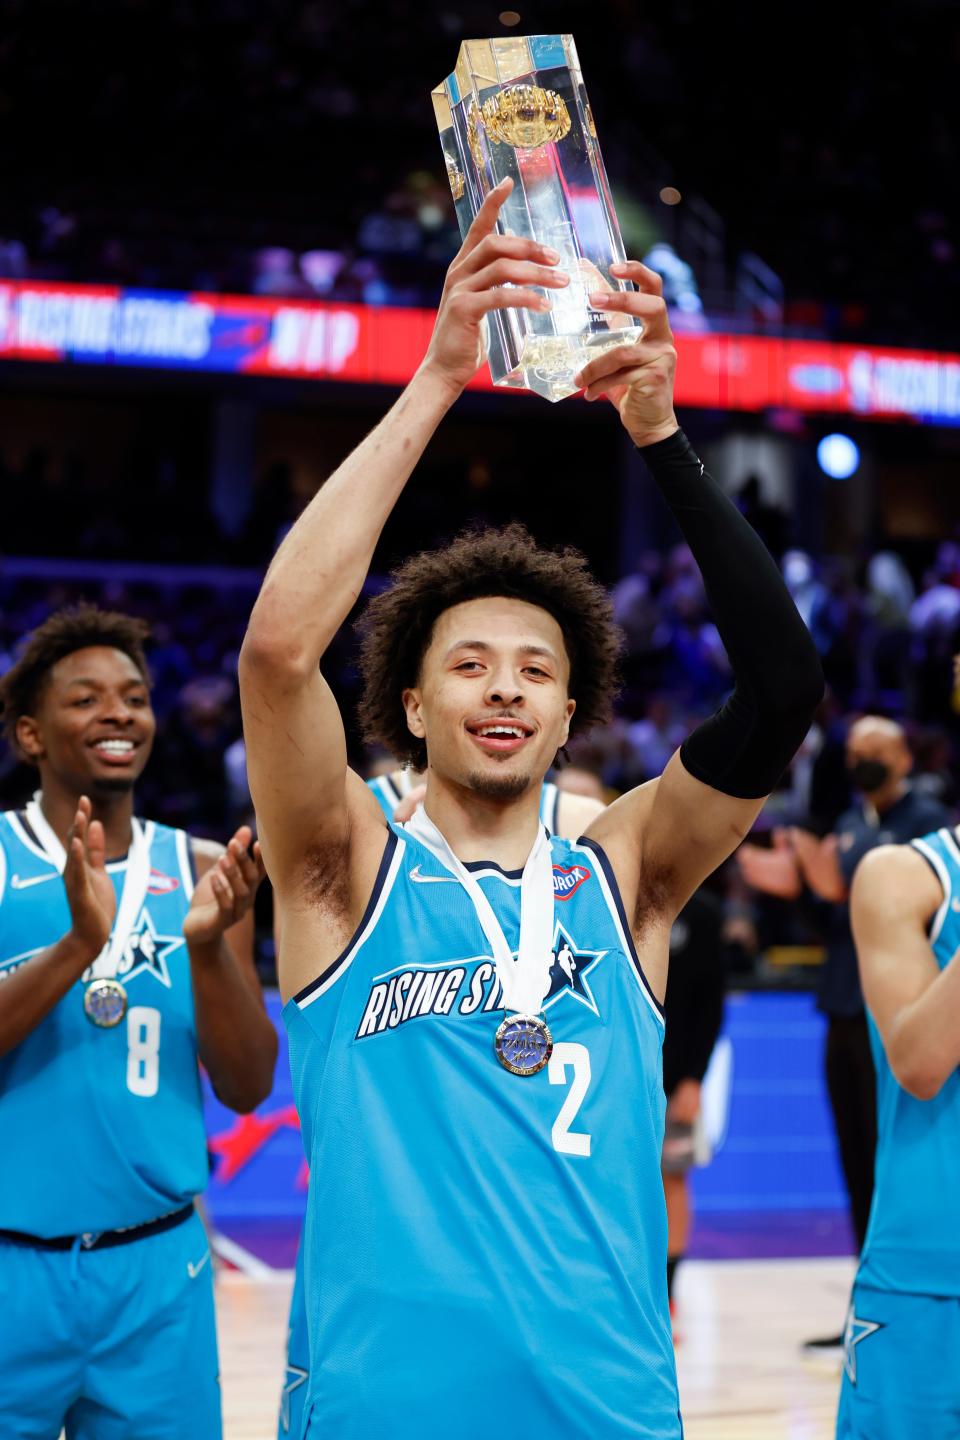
left=240, top=181, right=822, bottom=1440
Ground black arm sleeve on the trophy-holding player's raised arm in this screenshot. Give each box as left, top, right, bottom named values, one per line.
left=639, top=431, right=823, bottom=799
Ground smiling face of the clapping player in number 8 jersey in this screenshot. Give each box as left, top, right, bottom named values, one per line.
left=17, top=645, right=157, bottom=798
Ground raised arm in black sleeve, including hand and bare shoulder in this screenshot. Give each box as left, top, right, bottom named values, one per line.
left=580, top=262, right=823, bottom=919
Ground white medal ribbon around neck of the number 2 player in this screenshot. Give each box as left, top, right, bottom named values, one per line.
left=404, top=805, right=553, bottom=1015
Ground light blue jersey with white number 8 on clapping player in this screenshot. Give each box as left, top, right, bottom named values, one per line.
left=0, top=811, right=209, bottom=1237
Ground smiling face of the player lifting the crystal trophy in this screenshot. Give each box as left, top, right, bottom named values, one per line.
left=403, top=596, right=576, bottom=799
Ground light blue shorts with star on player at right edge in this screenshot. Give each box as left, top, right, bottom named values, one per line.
left=836, top=1283, right=960, bottom=1440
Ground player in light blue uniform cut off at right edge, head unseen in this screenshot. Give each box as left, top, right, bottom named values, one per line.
left=836, top=828, right=960, bottom=1440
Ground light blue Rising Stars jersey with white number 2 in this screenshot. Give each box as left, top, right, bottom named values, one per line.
left=284, top=828, right=682, bottom=1440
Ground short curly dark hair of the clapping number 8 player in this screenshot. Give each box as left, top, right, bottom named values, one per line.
left=0, top=603, right=150, bottom=753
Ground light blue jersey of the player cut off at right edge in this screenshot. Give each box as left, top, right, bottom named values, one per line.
left=858, top=829, right=960, bottom=1297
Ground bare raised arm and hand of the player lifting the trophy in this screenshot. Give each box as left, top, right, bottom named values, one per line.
left=240, top=181, right=569, bottom=921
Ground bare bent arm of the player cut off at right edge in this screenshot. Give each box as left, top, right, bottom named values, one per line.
left=851, top=845, right=960, bottom=1100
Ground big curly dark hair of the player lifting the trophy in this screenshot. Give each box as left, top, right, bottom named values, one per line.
left=357, top=524, right=620, bottom=770
